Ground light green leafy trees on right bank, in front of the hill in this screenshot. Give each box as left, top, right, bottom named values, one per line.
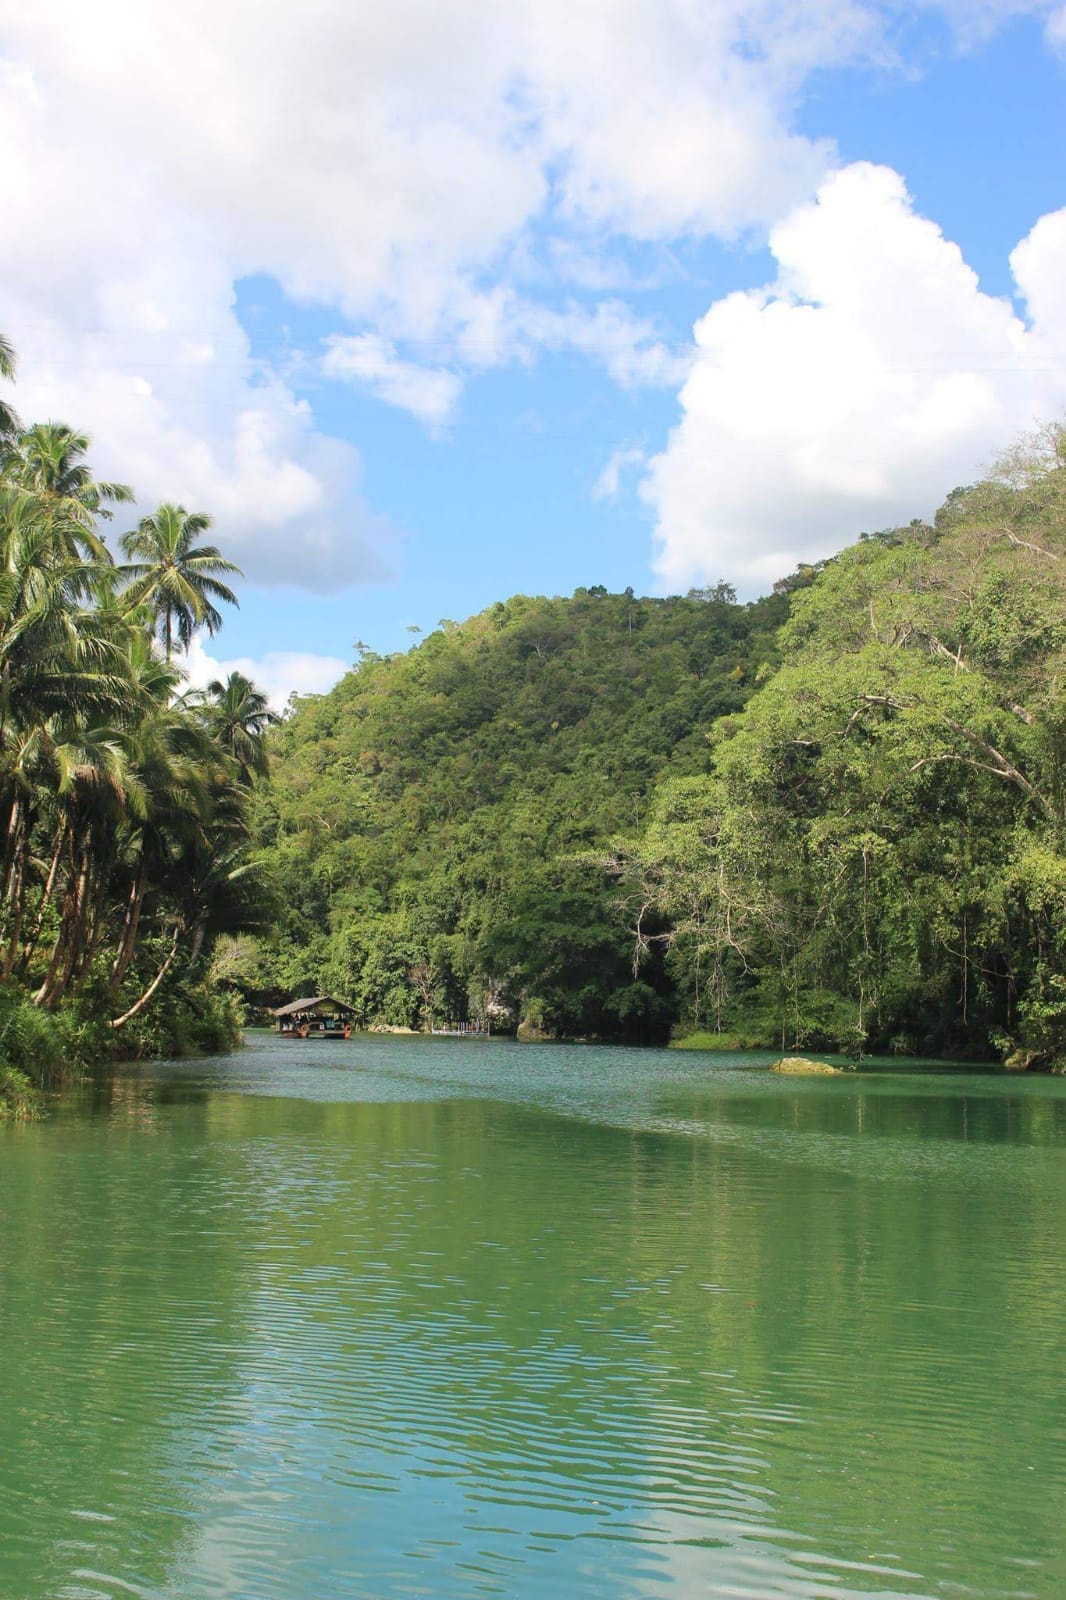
left=634, top=429, right=1066, bottom=1066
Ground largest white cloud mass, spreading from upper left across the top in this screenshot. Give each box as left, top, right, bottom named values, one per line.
left=0, top=0, right=1058, bottom=598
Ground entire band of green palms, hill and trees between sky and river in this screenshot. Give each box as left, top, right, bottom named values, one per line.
left=0, top=324, right=1066, bottom=1117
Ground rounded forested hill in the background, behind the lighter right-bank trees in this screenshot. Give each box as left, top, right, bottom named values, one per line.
left=240, top=587, right=787, bottom=1037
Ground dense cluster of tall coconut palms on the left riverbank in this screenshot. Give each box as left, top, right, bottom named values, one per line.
left=0, top=341, right=274, bottom=1115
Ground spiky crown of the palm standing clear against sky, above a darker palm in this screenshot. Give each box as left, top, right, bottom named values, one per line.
left=122, top=506, right=240, bottom=661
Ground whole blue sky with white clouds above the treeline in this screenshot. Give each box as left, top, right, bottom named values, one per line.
left=0, top=0, right=1066, bottom=699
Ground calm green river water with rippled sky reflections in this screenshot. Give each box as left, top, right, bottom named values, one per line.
left=0, top=1035, right=1066, bottom=1600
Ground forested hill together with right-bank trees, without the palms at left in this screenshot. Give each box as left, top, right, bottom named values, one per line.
left=240, top=429, right=1066, bottom=1066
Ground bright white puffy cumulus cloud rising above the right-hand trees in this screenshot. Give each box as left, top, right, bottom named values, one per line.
left=642, top=163, right=1066, bottom=589
